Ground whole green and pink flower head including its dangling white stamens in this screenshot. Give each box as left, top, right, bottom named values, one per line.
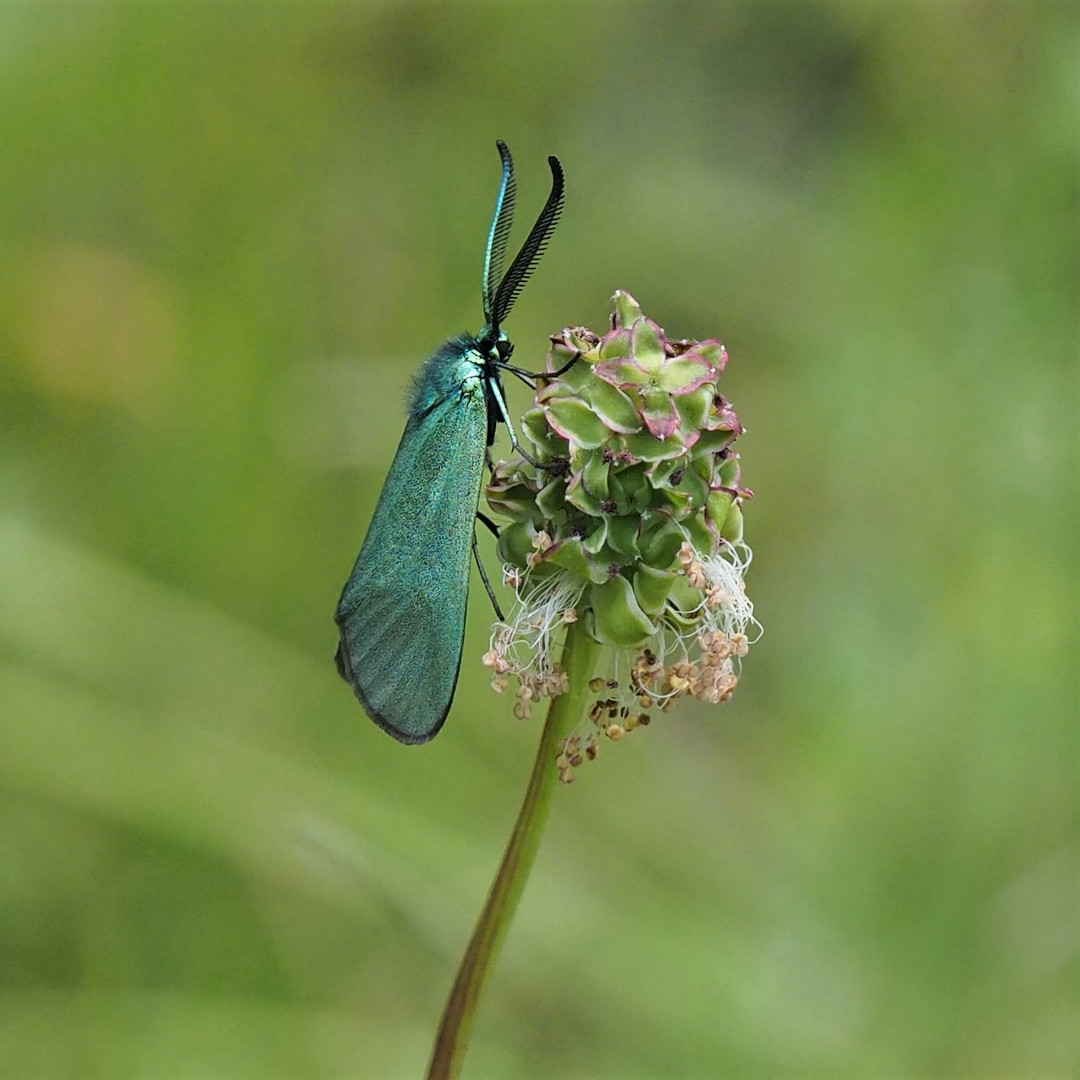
left=484, top=291, right=760, bottom=781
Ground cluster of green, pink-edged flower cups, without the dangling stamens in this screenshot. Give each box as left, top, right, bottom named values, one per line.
left=486, top=291, right=751, bottom=647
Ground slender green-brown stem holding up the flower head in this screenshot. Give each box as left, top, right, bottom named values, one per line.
left=428, top=622, right=599, bottom=1080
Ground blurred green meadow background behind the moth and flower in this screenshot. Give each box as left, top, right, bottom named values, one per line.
left=0, top=8, right=1080, bottom=1080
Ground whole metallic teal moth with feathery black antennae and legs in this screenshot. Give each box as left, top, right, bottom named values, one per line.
left=334, top=140, right=577, bottom=743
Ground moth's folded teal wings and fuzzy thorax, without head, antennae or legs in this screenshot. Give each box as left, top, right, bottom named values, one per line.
left=335, top=338, right=488, bottom=743
